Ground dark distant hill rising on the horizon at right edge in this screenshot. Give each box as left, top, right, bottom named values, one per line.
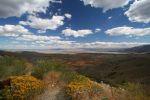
left=121, top=45, right=150, bottom=53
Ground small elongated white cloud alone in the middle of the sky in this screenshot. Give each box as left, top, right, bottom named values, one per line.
left=62, top=28, right=93, bottom=37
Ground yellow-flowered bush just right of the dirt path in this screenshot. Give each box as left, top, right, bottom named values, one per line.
left=65, top=73, right=102, bottom=100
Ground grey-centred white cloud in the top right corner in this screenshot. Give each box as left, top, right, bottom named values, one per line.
left=125, top=0, right=150, bottom=23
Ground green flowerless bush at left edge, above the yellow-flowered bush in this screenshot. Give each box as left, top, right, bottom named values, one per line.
left=0, top=56, right=28, bottom=78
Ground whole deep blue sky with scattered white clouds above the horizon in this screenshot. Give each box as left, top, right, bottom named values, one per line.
left=0, top=0, right=150, bottom=50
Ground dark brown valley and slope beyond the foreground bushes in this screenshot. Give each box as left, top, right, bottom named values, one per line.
left=0, top=52, right=150, bottom=84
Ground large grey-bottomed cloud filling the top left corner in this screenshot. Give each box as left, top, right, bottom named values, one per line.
left=0, top=0, right=60, bottom=18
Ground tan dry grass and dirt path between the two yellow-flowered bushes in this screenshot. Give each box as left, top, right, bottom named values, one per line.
left=33, top=71, right=65, bottom=100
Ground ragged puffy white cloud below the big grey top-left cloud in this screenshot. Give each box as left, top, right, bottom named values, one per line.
left=19, top=16, right=64, bottom=32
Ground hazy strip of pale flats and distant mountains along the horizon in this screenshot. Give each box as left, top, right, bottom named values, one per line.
left=0, top=45, right=150, bottom=54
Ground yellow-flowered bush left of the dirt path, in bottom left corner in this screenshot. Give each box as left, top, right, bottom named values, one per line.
left=1, top=76, right=44, bottom=100
